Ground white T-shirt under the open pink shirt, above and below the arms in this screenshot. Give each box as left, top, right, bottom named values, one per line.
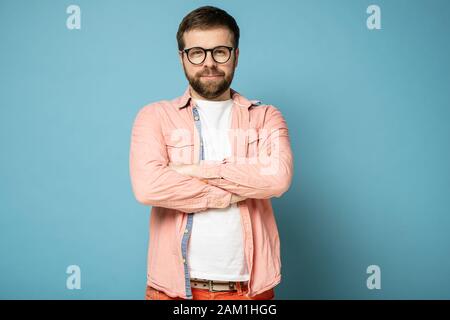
left=187, top=99, right=249, bottom=281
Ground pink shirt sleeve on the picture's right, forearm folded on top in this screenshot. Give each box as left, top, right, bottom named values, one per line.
left=199, top=106, right=293, bottom=199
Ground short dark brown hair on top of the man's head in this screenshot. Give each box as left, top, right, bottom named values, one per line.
left=177, top=6, right=240, bottom=50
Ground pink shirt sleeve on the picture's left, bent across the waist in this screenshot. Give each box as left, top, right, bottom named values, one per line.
left=129, top=105, right=231, bottom=212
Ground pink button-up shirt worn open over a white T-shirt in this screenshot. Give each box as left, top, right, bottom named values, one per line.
left=129, top=86, right=293, bottom=299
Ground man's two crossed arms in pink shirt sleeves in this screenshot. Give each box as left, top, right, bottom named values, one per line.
left=129, top=105, right=293, bottom=212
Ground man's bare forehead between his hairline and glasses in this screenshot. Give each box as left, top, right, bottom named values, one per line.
left=183, top=28, right=233, bottom=49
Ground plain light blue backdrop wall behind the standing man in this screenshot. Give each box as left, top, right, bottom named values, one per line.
left=0, top=0, right=450, bottom=299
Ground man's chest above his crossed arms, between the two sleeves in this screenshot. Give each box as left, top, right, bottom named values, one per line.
left=161, top=106, right=261, bottom=164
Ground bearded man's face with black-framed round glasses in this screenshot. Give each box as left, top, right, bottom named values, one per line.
left=180, top=28, right=239, bottom=100
